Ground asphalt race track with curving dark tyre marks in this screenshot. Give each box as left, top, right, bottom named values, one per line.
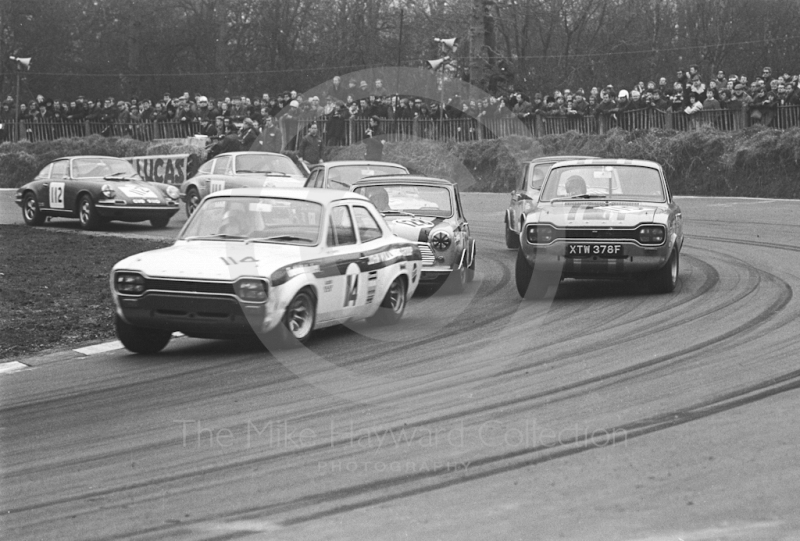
left=0, top=192, right=800, bottom=541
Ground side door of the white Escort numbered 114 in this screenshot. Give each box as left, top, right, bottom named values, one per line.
left=317, top=204, right=361, bottom=321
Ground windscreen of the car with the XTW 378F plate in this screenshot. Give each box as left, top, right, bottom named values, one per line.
left=539, top=165, right=666, bottom=203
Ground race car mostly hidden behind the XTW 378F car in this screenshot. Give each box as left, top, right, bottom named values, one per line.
left=504, top=156, right=592, bottom=249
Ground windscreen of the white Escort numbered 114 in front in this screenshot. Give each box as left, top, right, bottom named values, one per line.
left=180, top=196, right=324, bottom=246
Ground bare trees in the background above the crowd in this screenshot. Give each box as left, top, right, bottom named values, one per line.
left=0, top=0, right=800, bottom=99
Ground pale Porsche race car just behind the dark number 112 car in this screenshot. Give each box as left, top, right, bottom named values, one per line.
left=180, top=152, right=307, bottom=216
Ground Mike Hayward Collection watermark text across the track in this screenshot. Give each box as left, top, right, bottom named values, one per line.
left=173, top=419, right=628, bottom=452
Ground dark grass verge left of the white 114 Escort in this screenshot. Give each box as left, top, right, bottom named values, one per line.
left=0, top=225, right=172, bottom=359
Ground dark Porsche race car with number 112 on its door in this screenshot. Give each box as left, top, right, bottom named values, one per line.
left=16, top=156, right=180, bottom=229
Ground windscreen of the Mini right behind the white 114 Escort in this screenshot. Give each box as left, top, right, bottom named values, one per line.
left=354, top=184, right=453, bottom=218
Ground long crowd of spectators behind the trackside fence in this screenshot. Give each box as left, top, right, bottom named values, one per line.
left=6, top=65, right=800, bottom=145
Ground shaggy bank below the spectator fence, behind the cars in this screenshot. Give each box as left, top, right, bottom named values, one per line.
left=0, top=126, right=800, bottom=199
